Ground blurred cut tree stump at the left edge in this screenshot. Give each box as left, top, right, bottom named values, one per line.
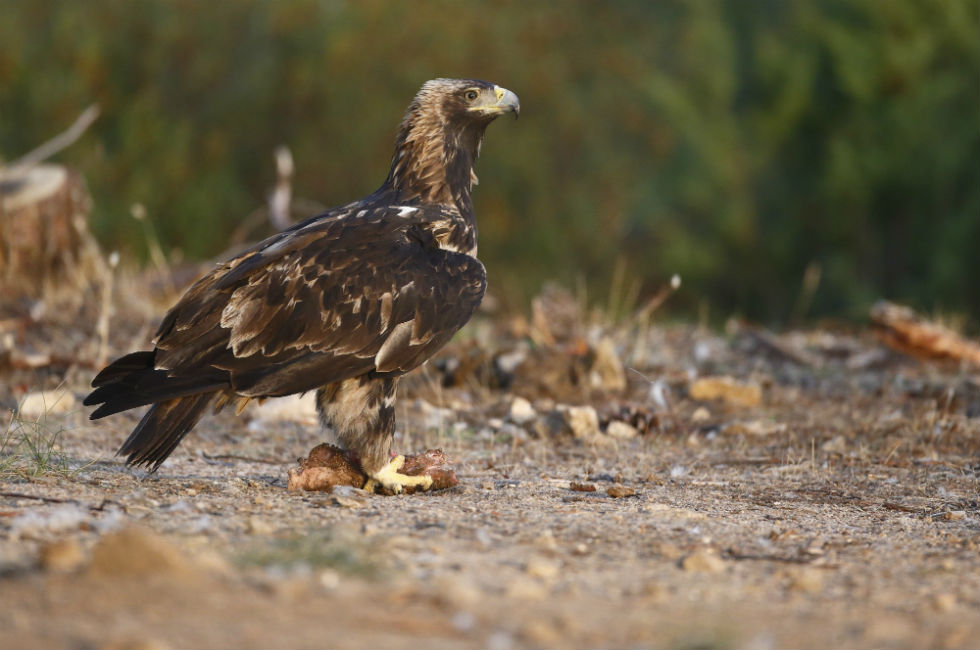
left=0, top=165, right=92, bottom=299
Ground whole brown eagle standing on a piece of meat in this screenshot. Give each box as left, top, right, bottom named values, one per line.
left=85, top=79, right=519, bottom=491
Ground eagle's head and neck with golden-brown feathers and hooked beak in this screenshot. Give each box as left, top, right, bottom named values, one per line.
left=385, top=79, right=521, bottom=211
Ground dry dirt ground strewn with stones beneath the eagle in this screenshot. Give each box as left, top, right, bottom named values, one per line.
left=0, top=280, right=980, bottom=650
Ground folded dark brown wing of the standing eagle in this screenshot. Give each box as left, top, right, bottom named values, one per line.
left=154, top=206, right=486, bottom=396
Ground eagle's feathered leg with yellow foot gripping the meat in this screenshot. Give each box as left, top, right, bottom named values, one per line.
left=316, top=377, right=432, bottom=494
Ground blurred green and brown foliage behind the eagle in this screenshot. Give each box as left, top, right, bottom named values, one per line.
left=0, top=0, right=980, bottom=324
